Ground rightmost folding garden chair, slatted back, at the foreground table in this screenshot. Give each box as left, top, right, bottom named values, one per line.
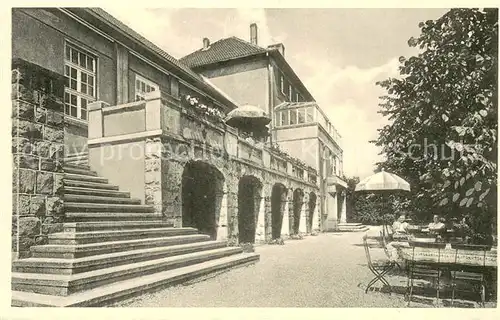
left=451, top=244, right=490, bottom=308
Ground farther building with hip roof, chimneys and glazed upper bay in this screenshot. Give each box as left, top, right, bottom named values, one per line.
left=180, top=23, right=347, bottom=231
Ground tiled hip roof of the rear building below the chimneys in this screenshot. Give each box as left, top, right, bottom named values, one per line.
left=180, top=37, right=267, bottom=68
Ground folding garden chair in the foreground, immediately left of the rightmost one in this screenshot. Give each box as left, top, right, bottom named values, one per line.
left=406, top=241, right=446, bottom=306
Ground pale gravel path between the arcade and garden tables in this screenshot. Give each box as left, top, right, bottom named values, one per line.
left=113, top=230, right=422, bottom=308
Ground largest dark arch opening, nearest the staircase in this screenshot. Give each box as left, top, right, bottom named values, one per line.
left=181, top=161, right=227, bottom=239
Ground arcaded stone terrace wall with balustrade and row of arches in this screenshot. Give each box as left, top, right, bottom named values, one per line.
left=88, top=91, right=319, bottom=243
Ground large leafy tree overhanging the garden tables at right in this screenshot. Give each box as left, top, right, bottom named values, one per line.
left=375, top=9, right=498, bottom=242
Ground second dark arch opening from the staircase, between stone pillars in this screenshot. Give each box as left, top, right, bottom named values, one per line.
left=238, top=175, right=262, bottom=243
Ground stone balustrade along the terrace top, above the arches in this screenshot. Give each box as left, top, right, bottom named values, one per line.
left=88, top=91, right=317, bottom=188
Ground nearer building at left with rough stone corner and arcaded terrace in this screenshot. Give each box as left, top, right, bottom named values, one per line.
left=12, top=8, right=321, bottom=257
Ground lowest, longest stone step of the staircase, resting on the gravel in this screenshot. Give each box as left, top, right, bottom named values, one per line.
left=11, top=253, right=259, bottom=307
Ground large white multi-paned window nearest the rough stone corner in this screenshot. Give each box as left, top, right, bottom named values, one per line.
left=64, top=45, right=97, bottom=120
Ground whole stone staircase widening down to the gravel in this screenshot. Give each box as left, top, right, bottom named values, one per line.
left=12, top=156, right=259, bottom=307
